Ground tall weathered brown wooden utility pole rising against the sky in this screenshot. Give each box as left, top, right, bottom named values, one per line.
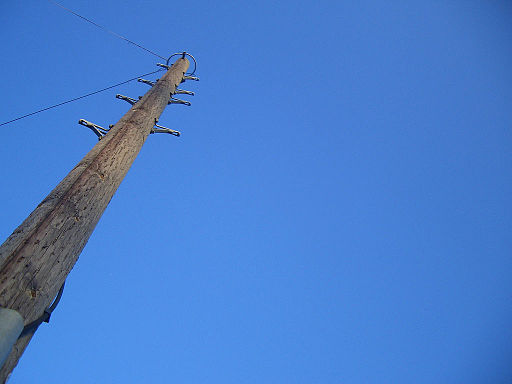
left=0, top=54, right=189, bottom=383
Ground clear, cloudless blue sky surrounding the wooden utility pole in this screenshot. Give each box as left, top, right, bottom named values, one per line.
left=0, top=0, right=512, bottom=384
